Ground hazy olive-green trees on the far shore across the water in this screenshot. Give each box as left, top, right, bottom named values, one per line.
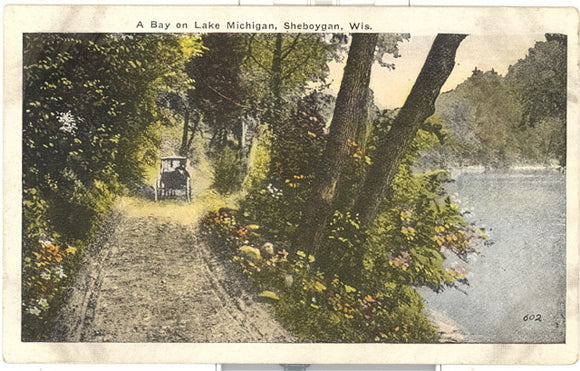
left=422, top=34, right=567, bottom=167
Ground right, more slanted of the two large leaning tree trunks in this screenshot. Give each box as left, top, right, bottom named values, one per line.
left=354, top=34, right=467, bottom=226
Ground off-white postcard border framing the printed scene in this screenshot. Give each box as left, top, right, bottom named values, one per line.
left=3, top=6, right=580, bottom=364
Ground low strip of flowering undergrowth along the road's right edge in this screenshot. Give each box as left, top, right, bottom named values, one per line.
left=203, top=209, right=436, bottom=342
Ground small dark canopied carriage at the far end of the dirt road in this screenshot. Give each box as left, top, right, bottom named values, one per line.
left=155, top=156, right=191, bottom=201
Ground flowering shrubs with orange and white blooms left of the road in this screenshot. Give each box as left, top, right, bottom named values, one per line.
left=22, top=173, right=116, bottom=341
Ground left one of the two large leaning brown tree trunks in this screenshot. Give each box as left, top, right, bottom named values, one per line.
left=295, top=34, right=378, bottom=256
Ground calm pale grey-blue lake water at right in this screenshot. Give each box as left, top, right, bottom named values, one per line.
left=420, top=170, right=566, bottom=343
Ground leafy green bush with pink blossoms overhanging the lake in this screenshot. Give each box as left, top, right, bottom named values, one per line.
left=361, top=165, right=485, bottom=291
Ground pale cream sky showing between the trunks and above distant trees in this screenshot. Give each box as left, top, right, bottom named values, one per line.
left=330, top=34, right=545, bottom=109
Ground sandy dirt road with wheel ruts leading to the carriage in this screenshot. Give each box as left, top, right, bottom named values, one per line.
left=52, top=199, right=294, bottom=342
